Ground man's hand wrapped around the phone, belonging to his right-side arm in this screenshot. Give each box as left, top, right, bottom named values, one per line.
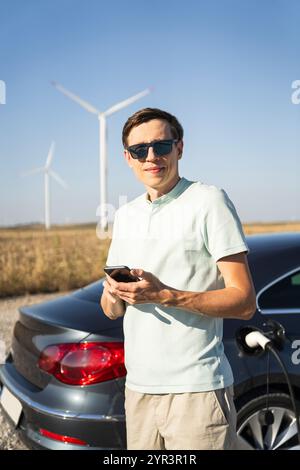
left=105, top=269, right=166, bottom=305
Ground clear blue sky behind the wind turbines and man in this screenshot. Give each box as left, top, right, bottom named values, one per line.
left=0, top=0, right=300, bottom=225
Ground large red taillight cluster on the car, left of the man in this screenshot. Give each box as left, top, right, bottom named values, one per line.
left=39, top=342, right=126, bottom=385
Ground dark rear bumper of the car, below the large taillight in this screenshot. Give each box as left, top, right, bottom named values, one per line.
left=0, top=364, right=126, bottom=450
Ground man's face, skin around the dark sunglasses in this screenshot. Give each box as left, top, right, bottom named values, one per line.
left=124, top=119, right=183, bottom=191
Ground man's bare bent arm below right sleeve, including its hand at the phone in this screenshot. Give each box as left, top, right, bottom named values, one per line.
left=102, top=253, right=256, bottom=320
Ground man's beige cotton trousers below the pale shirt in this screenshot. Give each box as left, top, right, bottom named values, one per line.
left=125, top=386, right=238, bottom=450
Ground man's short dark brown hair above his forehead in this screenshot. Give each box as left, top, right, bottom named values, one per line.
left=122, top=108, right=183, bottom=147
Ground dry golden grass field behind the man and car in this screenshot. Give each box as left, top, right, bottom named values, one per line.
left=0, top=222, right=300, bottom=298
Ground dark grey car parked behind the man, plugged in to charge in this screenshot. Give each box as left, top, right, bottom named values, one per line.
left=0, top=233, right=300, bottom=449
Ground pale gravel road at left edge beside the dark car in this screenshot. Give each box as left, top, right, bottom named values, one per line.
left=0, top=292, right=66, bottom=450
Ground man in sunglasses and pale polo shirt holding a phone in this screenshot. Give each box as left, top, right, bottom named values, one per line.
left=101, top=108, right=256, bottom=450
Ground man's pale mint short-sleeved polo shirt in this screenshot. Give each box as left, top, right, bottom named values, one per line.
left=107, top=178, right=249, bottom=394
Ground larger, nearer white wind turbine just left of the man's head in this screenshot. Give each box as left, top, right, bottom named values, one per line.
left=51, top=81, right=151, bottom=230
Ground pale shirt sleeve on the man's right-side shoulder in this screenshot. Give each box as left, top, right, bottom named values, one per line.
left=203, top=188, right=250, bottom=261
